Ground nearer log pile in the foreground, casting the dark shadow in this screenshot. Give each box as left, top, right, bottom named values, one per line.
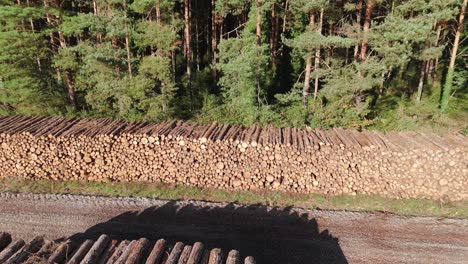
left=0, top=232, right=255, bottom=264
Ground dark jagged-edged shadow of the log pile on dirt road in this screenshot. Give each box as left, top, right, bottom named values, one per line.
left=66, top=202, right=347, bottom=264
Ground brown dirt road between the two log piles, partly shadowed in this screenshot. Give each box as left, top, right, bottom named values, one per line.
left=0, top=193, right=468, bottom=263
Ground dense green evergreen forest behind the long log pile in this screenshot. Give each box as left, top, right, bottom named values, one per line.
left=0, top=0, right=468, bottom=132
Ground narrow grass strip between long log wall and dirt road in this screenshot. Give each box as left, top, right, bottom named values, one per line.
left=0, top=178, right=468, bottom=219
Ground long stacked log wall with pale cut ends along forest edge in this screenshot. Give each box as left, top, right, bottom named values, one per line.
left=0, top=116, right=468, bottom=200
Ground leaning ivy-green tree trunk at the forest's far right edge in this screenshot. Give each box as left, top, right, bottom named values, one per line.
left=440, top=0, right=467, bottom=112
